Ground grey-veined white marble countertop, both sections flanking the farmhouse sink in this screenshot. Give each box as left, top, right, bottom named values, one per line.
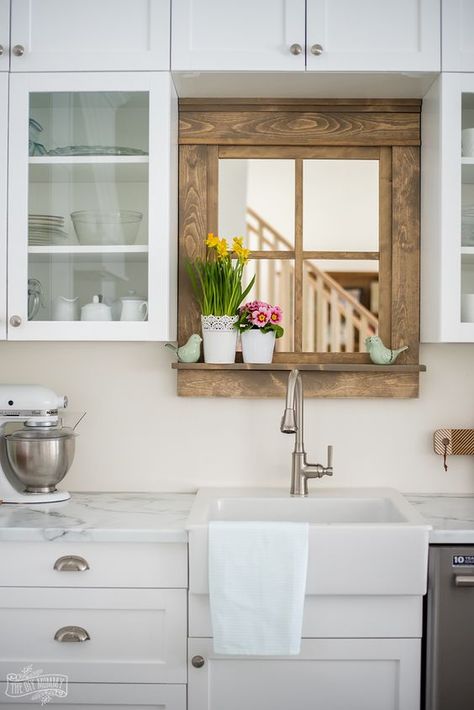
left=0, top=493, right=474, bottom=545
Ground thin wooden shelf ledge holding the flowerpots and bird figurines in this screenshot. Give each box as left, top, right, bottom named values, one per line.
left=171, top=362, right=426, bottom=373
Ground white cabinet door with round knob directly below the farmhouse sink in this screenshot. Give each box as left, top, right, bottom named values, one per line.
left=188, top=639, right=420, bottom=710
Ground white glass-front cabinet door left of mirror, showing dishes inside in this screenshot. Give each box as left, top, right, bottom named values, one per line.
left=8, top=73, right=176, bottom=340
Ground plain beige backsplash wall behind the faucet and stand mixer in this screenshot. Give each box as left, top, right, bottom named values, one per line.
left=0, top=343, right=474, bottom=494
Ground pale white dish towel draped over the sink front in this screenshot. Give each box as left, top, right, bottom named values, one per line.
left=209, top=521, right=309, bottom=656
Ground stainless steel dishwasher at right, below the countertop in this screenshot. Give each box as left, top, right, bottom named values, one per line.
left=425, top=545, right=474, bottom=710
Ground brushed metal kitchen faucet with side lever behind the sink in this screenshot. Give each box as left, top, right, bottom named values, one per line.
left=280, top=370, right=333, bottom=496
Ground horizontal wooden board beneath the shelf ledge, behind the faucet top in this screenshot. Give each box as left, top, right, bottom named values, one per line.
left=177, top=370, right=419, bottom=401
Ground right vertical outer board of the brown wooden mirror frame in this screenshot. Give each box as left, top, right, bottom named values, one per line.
left=391, top=146, right=420, bottom=364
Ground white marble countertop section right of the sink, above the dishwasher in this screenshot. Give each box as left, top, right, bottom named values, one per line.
left=407, top=494, right=474, bottom=545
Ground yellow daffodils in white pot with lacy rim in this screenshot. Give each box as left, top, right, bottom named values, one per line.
left=186, top=233, right=255, bottom=364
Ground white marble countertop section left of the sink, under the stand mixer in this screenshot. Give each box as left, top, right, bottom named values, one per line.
left=0, top=493, right=194, bottom=542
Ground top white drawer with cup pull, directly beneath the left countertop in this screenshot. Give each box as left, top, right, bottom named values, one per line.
left=0, top=542, right=187, bottom=588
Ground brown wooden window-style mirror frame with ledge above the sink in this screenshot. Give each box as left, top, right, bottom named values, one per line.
left=174, top=99, right=425, bottom=398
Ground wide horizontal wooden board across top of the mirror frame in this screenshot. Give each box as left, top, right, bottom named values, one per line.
left=179, top=110, right=420, bottom=146
